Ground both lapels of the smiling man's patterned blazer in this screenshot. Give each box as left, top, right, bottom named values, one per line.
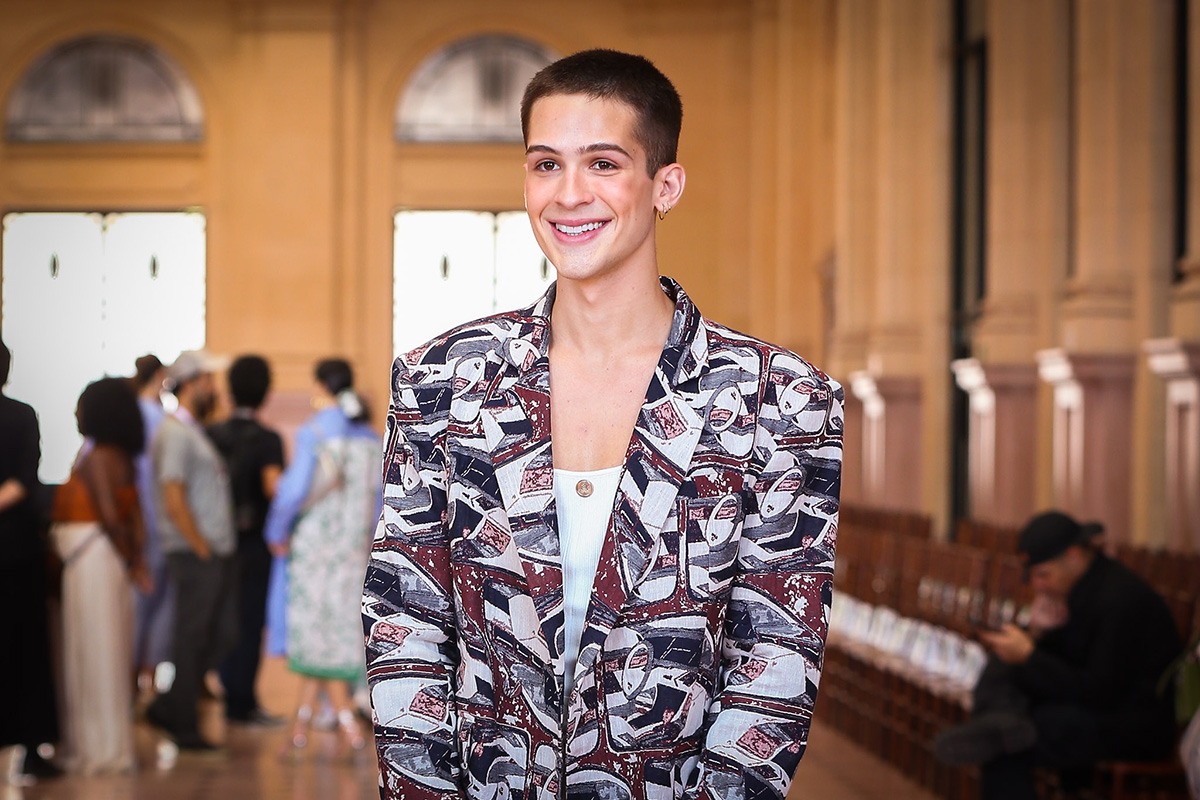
left=480, top=278, right=708, bottom=695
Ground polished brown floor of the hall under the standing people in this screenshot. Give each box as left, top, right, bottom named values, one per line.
left=0, top=660, right=932, bottom=800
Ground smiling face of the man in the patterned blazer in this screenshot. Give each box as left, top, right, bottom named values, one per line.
left=524, top=95, right=661, bottom=286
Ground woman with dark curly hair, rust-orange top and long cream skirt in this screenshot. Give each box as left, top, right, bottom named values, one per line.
left=50, top=378, right=150, bottom=775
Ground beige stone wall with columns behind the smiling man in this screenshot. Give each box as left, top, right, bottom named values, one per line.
left=0, top=0, right=1200, bottom=543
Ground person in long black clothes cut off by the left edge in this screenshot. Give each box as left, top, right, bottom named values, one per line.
left=0, top=342, right=59, bottom=782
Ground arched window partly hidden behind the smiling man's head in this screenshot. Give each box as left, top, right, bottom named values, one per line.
left=396, top=36, right=554, bottom=142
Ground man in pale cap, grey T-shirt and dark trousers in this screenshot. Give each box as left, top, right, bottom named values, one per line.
left=146, top=350, right=238, bottom=752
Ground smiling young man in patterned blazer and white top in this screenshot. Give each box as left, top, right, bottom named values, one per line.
left=362, top=50, right=841, bottom=800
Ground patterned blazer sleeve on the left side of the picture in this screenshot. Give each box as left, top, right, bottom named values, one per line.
left=362, top=356, right=461, bottom=800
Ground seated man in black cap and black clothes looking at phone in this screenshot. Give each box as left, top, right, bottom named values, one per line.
left=935, top=511, right=1181, bottom=800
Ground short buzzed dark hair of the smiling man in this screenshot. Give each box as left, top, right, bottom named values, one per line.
left=521, top=49, right=683, bottom=178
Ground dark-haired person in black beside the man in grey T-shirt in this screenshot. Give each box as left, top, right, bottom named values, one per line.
left=209, top=355, right=283, bottom=726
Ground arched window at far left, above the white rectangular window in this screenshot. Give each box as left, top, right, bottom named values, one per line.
left=5, top=36, right=204, bottom=142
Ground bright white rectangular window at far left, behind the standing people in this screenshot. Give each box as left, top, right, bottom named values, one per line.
left=4, top=213, right=205, bottom=483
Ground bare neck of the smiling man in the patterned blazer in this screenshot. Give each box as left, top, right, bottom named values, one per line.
left=550, top=270, right=674, bottom=355
